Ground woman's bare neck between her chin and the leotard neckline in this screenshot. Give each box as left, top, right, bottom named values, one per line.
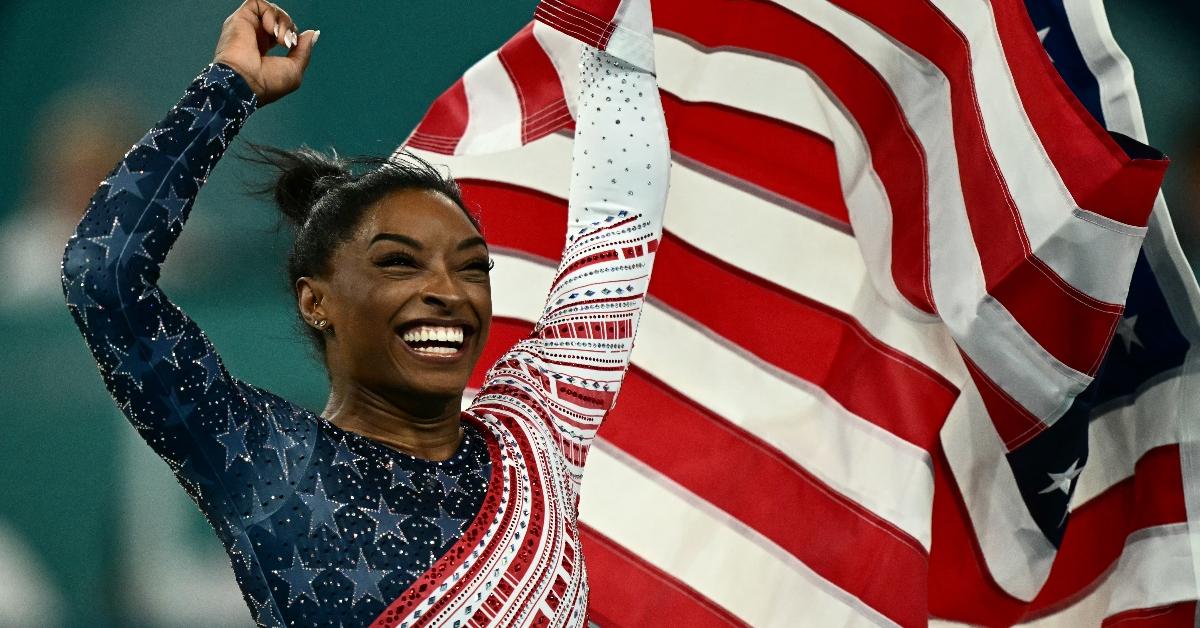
left=322, top=382, right=462, bottom=461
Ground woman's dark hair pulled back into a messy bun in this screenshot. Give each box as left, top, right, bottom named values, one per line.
left=241, top=143, right=481, bottom=357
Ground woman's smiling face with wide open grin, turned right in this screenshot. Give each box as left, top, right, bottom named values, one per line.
left=314, top=190, right=492, bottom=410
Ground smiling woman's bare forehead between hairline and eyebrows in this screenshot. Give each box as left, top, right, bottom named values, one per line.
left=358, top=190, right=479, bottom=244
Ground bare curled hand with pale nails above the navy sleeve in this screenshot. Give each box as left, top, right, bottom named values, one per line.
left=212, top=0, right=320, bottom=106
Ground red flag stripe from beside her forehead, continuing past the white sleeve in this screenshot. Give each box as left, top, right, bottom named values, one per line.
left=460, top=180, right=958, bottom=449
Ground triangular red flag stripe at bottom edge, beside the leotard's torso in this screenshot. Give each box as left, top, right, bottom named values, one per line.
left=580, top=524, right=746, bottom=628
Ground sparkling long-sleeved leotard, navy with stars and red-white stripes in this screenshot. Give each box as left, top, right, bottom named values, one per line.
left=62, top=20, right=670, bottom=626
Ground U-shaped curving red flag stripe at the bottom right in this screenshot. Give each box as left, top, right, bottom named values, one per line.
left=929, top=445, right=1187, bottom=626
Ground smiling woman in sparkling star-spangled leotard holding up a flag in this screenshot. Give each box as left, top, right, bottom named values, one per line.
left=62, top=0, right=670, bottom=626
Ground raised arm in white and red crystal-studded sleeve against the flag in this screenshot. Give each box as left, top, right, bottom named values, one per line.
left=475, top=19, right=671, bottom=480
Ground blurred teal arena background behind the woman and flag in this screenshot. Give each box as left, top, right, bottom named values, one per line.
left=0, top=0, right=1200, bottom=627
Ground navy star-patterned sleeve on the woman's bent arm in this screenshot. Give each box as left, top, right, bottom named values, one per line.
left=62, top=64, right=257, bottom=496
